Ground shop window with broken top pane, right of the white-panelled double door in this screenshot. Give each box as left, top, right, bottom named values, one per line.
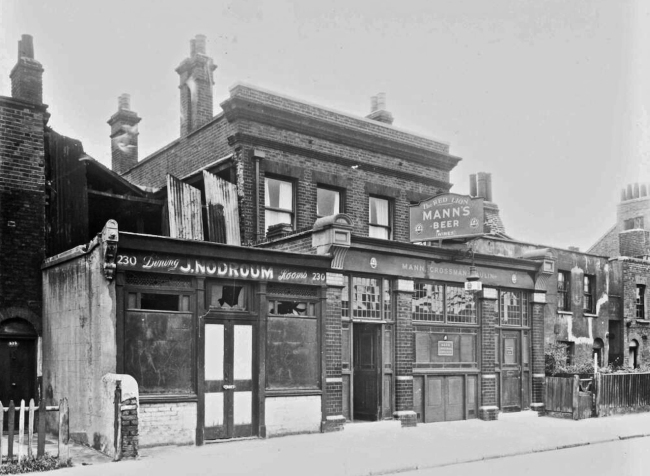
left=266, top=296, right=321, bottom=390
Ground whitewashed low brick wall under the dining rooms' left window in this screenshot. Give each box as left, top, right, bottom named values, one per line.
left=140, top=402, right=196, bottom=448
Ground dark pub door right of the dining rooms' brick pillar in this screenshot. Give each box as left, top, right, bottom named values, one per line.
left=352, top=323, right=382, bottom=421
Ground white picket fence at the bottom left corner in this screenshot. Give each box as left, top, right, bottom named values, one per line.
left=0, top=398, right=70, bottom=464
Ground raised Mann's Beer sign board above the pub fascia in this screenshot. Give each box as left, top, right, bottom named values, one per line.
left=410, top=193, right=484, bottom=243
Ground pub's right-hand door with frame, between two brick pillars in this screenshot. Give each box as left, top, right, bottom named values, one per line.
left=500, top=330, right=530, bottom=412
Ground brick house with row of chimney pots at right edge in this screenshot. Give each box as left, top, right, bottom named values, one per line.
left=589, top=183, right=650, bottom=367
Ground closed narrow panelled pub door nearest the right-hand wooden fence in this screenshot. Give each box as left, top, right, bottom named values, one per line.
left=501, top=331, right=523, bottom=412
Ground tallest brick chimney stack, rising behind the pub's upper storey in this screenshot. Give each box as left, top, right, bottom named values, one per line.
left=176, top=35, right=217, bottom=137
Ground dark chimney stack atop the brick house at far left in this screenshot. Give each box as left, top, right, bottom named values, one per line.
left=9, top=35, right=44, bottom=104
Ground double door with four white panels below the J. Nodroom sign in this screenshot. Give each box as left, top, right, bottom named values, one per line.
left=204, top=319, right=257, bottom=440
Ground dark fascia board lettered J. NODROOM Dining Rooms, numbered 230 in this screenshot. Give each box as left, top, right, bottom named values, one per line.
left=117, top=251, right=326, bottom=284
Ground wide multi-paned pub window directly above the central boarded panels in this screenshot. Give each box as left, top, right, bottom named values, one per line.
left=411, top=282, right=477, bottom=324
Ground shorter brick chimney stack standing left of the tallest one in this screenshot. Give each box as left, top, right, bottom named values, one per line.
left=108, top=94, right=142, bottom=174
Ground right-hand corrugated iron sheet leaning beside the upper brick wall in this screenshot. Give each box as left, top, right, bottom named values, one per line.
left=203, top=170, right=241, bottom=246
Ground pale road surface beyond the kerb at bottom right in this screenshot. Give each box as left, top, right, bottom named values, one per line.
left=400, top=438, right=650, bottom=476
